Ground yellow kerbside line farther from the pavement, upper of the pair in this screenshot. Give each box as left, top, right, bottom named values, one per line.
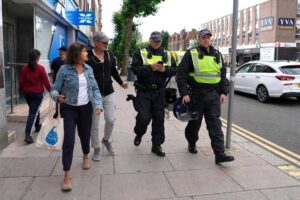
left=221, top=118, right=300, bottom=160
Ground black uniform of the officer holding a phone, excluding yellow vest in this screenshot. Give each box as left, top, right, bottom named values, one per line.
left=131, top=46, right=176, bottom=152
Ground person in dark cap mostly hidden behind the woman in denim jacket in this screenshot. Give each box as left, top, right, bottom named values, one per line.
left=51, top=46, right=68, bottom=119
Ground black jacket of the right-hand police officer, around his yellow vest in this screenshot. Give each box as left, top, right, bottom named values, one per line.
left=177, top=46, right=228, bottom=96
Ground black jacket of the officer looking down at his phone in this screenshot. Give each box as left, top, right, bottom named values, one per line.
left=131, top=46, right=176, bottom=88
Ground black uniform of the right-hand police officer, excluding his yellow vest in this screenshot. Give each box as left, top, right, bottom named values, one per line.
left=177, top=46, right=228, bottom=155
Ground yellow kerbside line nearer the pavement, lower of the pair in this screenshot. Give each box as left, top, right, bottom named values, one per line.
left=221, top=119, right=300, bottom=166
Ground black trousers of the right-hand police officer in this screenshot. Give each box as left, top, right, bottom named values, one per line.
left=185, top=90, right=225, bottom=154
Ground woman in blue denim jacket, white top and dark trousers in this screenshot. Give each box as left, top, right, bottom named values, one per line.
left=51, top=43, right=103, bottom=191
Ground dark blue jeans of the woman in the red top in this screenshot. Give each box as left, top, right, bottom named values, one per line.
left=25, top=93, right=43, bottom=136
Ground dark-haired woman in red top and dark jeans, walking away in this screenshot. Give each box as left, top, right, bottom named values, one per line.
left=20, top=49, right=51, bottom=144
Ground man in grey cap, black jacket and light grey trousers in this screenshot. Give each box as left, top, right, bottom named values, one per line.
left=87, top=31, right=128, bottom=161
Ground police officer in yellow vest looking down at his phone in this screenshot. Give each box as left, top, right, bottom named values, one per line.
left=131, top=31, right=176, bottom=157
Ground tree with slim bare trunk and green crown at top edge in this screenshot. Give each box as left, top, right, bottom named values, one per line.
left=121, top=0, right=164, bottom=75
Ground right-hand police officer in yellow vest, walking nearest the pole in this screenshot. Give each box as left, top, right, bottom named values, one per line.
left=177, top=29, right=234, bottom=164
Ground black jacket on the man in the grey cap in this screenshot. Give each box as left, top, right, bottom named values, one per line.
left=86, top=50, right=123, bottom=97
